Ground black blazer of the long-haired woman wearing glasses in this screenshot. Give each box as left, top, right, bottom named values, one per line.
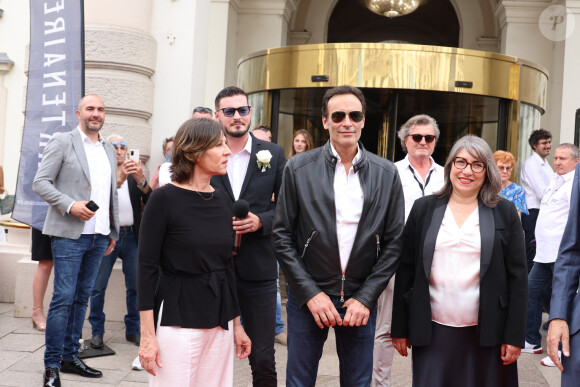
left=392, top=195, right=528, bottom=347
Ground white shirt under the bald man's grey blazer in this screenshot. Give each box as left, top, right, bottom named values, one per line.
left=77, top=127, right=111, bottom=235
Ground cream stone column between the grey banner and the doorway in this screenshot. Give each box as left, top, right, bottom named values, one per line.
left=85, top=0, right=156, bottom=170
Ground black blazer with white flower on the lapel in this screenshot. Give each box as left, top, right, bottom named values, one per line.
left=211, top=133, right=286, bottom=281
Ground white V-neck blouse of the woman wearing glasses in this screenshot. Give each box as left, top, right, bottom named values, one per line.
left=429, top=206, right=481, bottom=327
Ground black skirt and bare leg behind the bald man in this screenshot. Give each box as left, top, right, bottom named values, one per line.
left=30, top=228, right=52, bottom=332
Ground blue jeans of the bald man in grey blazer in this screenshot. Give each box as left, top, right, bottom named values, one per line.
left=44, top=234, right=109, bottom=369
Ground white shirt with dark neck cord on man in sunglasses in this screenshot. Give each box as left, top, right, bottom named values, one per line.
left=395, top=155, right=444, bottom=222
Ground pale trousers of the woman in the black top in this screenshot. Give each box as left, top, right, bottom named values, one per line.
left=149, top=304, right=234, bottom=387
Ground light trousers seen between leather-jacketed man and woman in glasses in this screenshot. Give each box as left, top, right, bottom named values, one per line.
left=371, top=276, right=395, bottom=387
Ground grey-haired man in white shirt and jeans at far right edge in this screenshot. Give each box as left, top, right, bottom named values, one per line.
left=522, top=144, right=580, bottom=365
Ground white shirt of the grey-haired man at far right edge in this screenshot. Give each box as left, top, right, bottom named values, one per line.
left=534, top=170, right=575, bottom=263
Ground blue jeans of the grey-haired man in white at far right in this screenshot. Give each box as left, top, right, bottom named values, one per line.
left=526, top=262, right=554, bottom=345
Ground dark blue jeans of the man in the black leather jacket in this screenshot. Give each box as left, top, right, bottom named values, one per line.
left=286, top=289, right=377, bottom=387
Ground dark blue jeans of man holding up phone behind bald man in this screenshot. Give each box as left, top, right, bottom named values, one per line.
left=89, top=226, right=140, bottom=335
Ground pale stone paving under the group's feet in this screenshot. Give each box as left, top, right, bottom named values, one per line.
left=0, top=303, right=560, bottom=387
